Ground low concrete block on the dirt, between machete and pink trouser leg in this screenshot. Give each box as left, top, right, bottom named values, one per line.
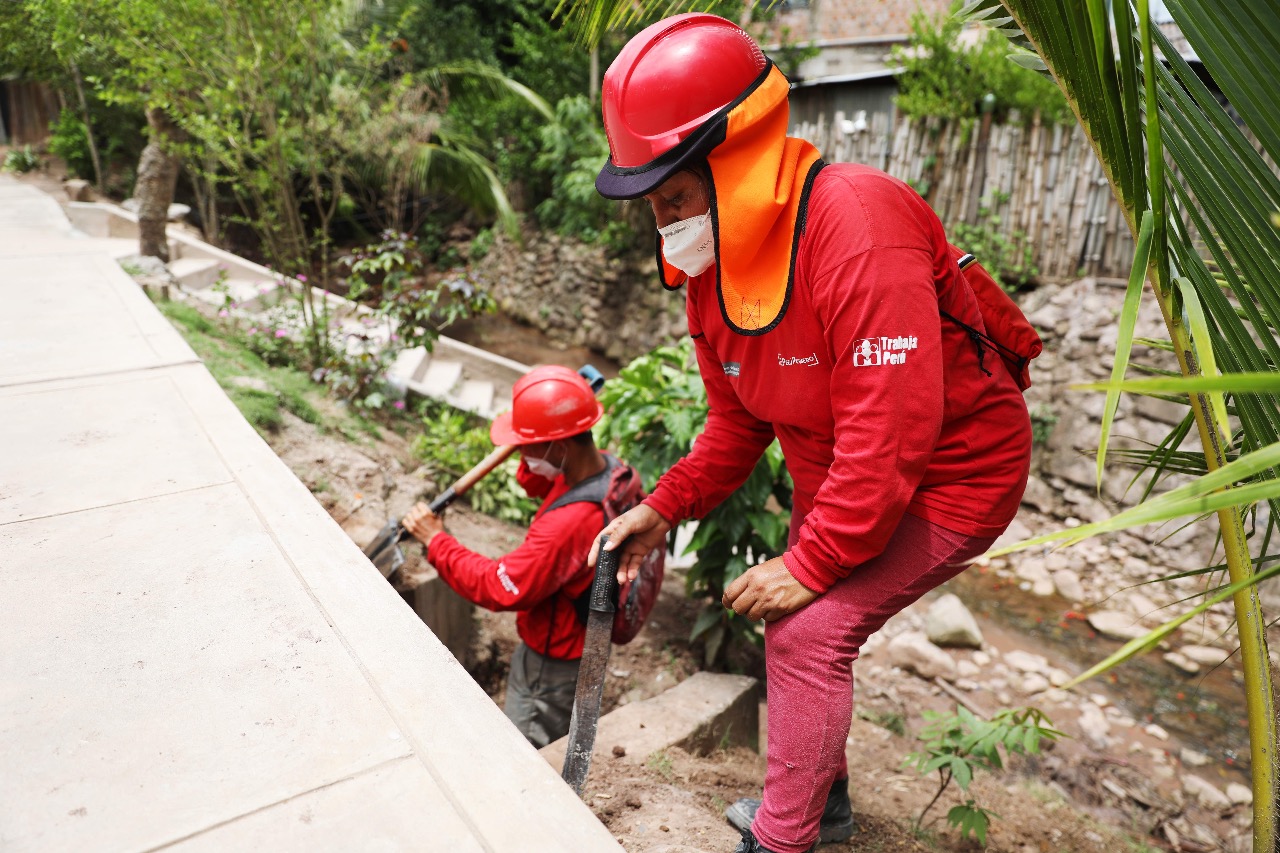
left=539, top=672, right=760, bottom=770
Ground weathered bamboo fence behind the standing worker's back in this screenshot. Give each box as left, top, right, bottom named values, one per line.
left=791, top=111, right=1134, bottom=280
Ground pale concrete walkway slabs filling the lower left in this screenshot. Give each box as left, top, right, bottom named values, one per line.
left=0, top=177, right=620, bottom=853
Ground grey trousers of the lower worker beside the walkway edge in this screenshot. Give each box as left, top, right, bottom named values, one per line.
left=503, top=643, right=580, bottom=749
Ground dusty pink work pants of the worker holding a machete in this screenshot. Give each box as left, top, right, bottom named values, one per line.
left=751, top=515, right=995, bottom=853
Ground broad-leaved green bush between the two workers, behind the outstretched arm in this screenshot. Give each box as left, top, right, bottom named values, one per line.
left=596, top=341, right=792, bottom=666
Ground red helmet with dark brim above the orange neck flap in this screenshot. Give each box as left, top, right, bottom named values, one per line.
left=595, top=13, right=769, bottom=199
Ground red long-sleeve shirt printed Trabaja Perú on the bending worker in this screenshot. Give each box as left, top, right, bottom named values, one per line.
left=645, top=164, right=1030, bottom=592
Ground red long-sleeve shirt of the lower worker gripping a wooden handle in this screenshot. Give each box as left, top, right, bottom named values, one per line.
left=426, top=460, right=604, bottom=660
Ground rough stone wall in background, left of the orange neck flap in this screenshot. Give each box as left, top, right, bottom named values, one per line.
left=474, top=225, right=689, bottom=364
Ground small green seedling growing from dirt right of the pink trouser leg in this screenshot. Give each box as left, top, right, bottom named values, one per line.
left=902, top=706, right=1062, bottom=844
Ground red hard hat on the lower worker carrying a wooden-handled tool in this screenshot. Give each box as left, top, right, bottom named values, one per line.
left=489, top=365, right=604, bottom=444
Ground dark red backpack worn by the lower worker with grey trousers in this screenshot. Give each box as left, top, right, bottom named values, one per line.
left=547, top=453, right=667, bottom=646
